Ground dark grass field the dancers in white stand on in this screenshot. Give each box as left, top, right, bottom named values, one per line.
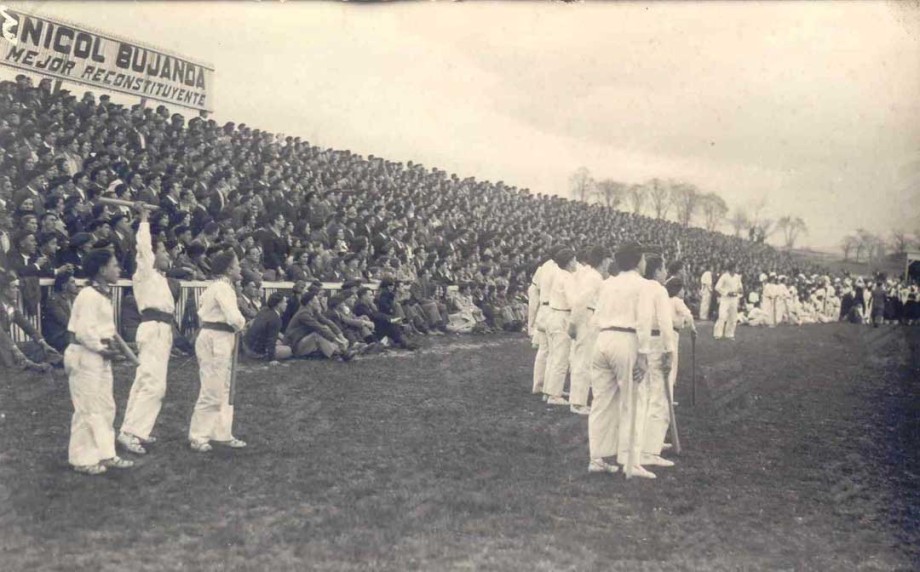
left=0, top=324, right=920, bottom=571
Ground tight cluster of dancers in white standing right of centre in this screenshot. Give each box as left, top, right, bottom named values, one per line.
left=528, top=243, right=696, bottom=479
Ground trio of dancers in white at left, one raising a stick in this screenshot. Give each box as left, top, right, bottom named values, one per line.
left=64, top=203, right=246, bottom=475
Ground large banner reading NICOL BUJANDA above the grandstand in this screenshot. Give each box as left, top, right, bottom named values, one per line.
left=0, top=6, right=214, bottom=111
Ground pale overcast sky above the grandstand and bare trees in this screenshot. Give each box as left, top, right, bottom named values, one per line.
left=7, top=0, right=920, bottom=247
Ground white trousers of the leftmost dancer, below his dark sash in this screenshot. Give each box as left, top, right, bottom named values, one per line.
left=64, top=344, right=115, bottom=466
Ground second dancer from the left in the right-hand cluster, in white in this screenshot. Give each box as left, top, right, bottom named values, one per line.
left=543, top=248, right=577, bottom=405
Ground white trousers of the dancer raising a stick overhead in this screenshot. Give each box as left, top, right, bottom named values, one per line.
left=121, top=322, right=172, bottom=439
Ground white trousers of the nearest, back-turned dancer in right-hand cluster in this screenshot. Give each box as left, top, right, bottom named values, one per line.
left=588, top=331, right=644, bottom=462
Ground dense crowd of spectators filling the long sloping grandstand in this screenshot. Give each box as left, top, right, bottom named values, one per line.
left=0, top=76, right=828, bottom=368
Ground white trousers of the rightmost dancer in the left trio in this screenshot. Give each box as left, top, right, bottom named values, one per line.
left=188, top=330, right=234, bottom=441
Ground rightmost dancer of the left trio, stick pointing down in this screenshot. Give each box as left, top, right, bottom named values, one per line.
left=188, top=251, right=246, bottom=453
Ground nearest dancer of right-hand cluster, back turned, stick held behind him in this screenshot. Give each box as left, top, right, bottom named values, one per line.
left=588, top=243, right=655, bottom=478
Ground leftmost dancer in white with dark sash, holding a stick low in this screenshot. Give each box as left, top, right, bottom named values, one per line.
left=64, top=250, right=134, bottom=475
